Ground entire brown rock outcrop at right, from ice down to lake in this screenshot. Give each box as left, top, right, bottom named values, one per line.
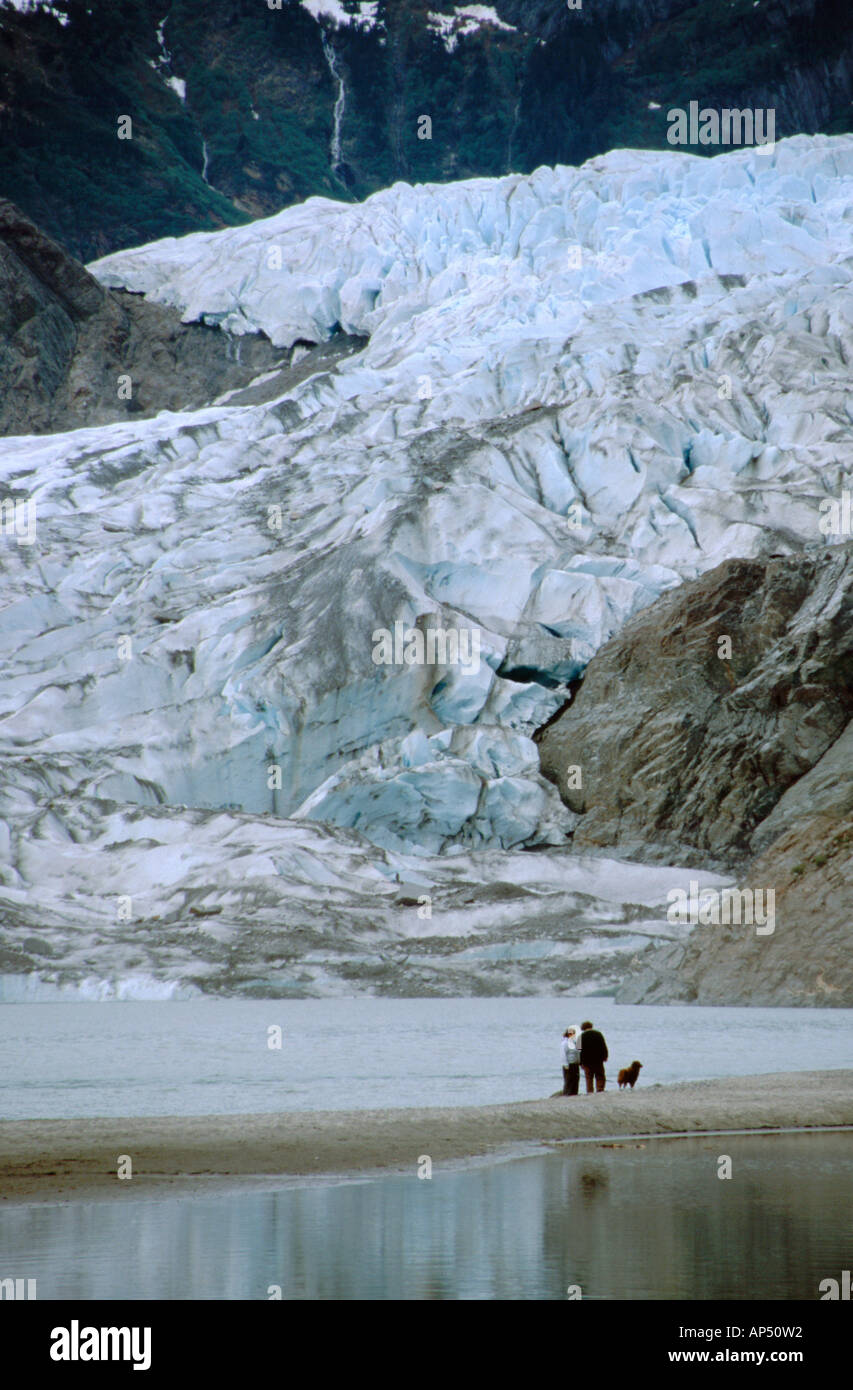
left=540, top=543, right=853, bottom=1008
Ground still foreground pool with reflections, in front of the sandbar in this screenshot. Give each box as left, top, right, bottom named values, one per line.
left=0, top=1131, right=853, bottom=1295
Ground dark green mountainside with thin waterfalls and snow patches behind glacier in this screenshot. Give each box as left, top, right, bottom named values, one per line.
left=0, top=0, right=853, bottom=260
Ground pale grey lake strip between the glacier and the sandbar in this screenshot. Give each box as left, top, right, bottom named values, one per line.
left=0, top=997, right=853, bottom=1119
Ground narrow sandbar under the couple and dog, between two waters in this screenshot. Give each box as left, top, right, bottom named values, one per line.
left=0, top=1070, right=853, bottom=1201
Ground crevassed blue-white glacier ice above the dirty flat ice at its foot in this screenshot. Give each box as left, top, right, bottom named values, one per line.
left=0, top=136, right=853, bottom=995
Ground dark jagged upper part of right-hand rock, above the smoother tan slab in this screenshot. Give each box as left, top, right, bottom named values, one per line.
left=540, top=546, right=853, bottom=863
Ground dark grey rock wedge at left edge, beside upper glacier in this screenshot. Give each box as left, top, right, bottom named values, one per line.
left=0, top=202, right=288, bottom=435
